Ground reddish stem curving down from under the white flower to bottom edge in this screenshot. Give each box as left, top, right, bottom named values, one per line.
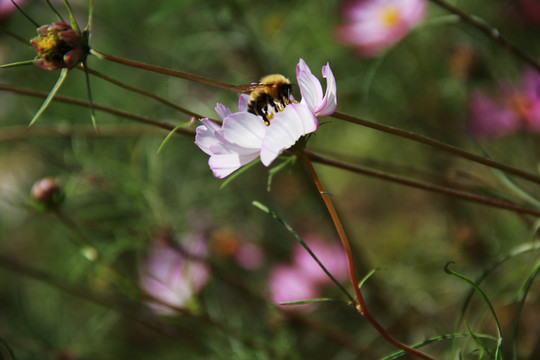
left=299, top=152, right=433, bottom=360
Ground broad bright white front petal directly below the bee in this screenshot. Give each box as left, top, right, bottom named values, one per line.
left=261, top=103, right=319, bottom=166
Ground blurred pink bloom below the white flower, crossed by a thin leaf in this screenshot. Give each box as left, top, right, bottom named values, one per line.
left=269, top=235, right=347, bottom=310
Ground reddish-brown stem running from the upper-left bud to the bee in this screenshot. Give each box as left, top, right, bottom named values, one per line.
left=90, top=49, right=234, bottom=90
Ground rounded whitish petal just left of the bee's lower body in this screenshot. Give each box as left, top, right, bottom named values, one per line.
left=222, top=112, right=266, bottom=149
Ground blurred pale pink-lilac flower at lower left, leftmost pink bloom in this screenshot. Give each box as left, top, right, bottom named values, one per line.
left=140, top=236, right=210, bottom=315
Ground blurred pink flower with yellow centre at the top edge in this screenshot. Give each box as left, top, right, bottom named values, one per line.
left=337, top=0, right=427, bottom=57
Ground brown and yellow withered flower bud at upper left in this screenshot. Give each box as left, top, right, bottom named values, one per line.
left=30, top=22, right=88, bottom=70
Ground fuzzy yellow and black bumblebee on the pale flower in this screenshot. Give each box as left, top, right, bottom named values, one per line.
left=231, top=74, right=292, bottom=125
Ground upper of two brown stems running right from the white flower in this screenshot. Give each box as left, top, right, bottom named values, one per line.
left=332, top=112, right=540, bottom=184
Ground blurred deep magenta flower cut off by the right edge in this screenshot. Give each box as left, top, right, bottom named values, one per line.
left=467, top=70, right=540, bottom=139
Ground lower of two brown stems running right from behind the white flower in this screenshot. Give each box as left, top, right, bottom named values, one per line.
left=306, top=151, right=540, bottom=217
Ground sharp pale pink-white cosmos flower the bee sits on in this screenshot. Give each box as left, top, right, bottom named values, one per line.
left=195, top=59, right=337, bottom=179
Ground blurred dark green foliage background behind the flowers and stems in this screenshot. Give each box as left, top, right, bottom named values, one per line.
left=0, top=0, right=540, bottom=360
